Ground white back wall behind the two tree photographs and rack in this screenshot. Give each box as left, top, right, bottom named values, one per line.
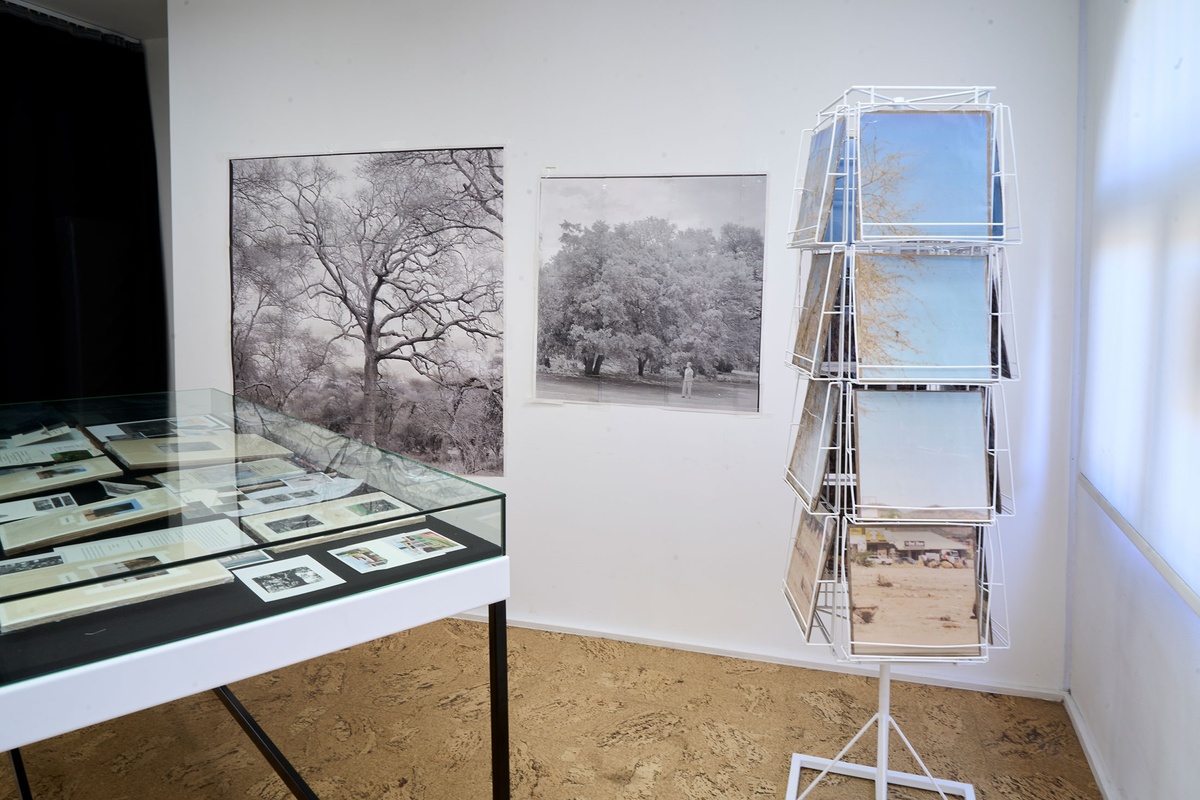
left=169, top=0, right=1079, bottom=693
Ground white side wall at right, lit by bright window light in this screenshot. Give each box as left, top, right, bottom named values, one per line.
left=1068, top=0, right=1200, bottom=800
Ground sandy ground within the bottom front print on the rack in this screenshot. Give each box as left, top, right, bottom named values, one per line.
left=850, top=564, right=979, bottom=655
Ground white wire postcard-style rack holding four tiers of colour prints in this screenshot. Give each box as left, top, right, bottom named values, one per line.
left=784, top=86, right=1020, bottom=800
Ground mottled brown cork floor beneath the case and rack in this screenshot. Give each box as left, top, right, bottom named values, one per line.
left=0, top=620, right=1100, bottom=800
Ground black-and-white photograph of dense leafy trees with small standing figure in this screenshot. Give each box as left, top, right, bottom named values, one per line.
left=536, top=175, right=767, bottom=411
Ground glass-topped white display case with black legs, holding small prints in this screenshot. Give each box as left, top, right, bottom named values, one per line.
left=0, top=390, right=508, bottom=796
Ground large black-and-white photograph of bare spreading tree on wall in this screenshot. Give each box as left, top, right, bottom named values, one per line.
left=230, top=148, right=504, bottom=475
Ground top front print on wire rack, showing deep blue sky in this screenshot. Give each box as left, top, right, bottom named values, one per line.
left=857, top=110, right=996, bottom=241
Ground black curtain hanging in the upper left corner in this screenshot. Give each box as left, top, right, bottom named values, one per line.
left=0, top=4, right=168, bottom=403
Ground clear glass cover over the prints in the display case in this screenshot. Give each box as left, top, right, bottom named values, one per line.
left=0, top=390, right=504, bottom=647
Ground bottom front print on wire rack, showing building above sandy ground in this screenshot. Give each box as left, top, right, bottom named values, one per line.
left=846, top=525, right=983, bottom=658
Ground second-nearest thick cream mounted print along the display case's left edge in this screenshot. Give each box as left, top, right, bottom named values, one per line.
left=0, top=489, right=181, bottom=555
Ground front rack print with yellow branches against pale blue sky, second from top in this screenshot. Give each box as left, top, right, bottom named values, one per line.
left=854, top=253, right=992, bottom=384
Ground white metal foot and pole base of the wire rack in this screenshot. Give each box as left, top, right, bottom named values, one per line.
left=785, top=664, right=976, bottom=800
